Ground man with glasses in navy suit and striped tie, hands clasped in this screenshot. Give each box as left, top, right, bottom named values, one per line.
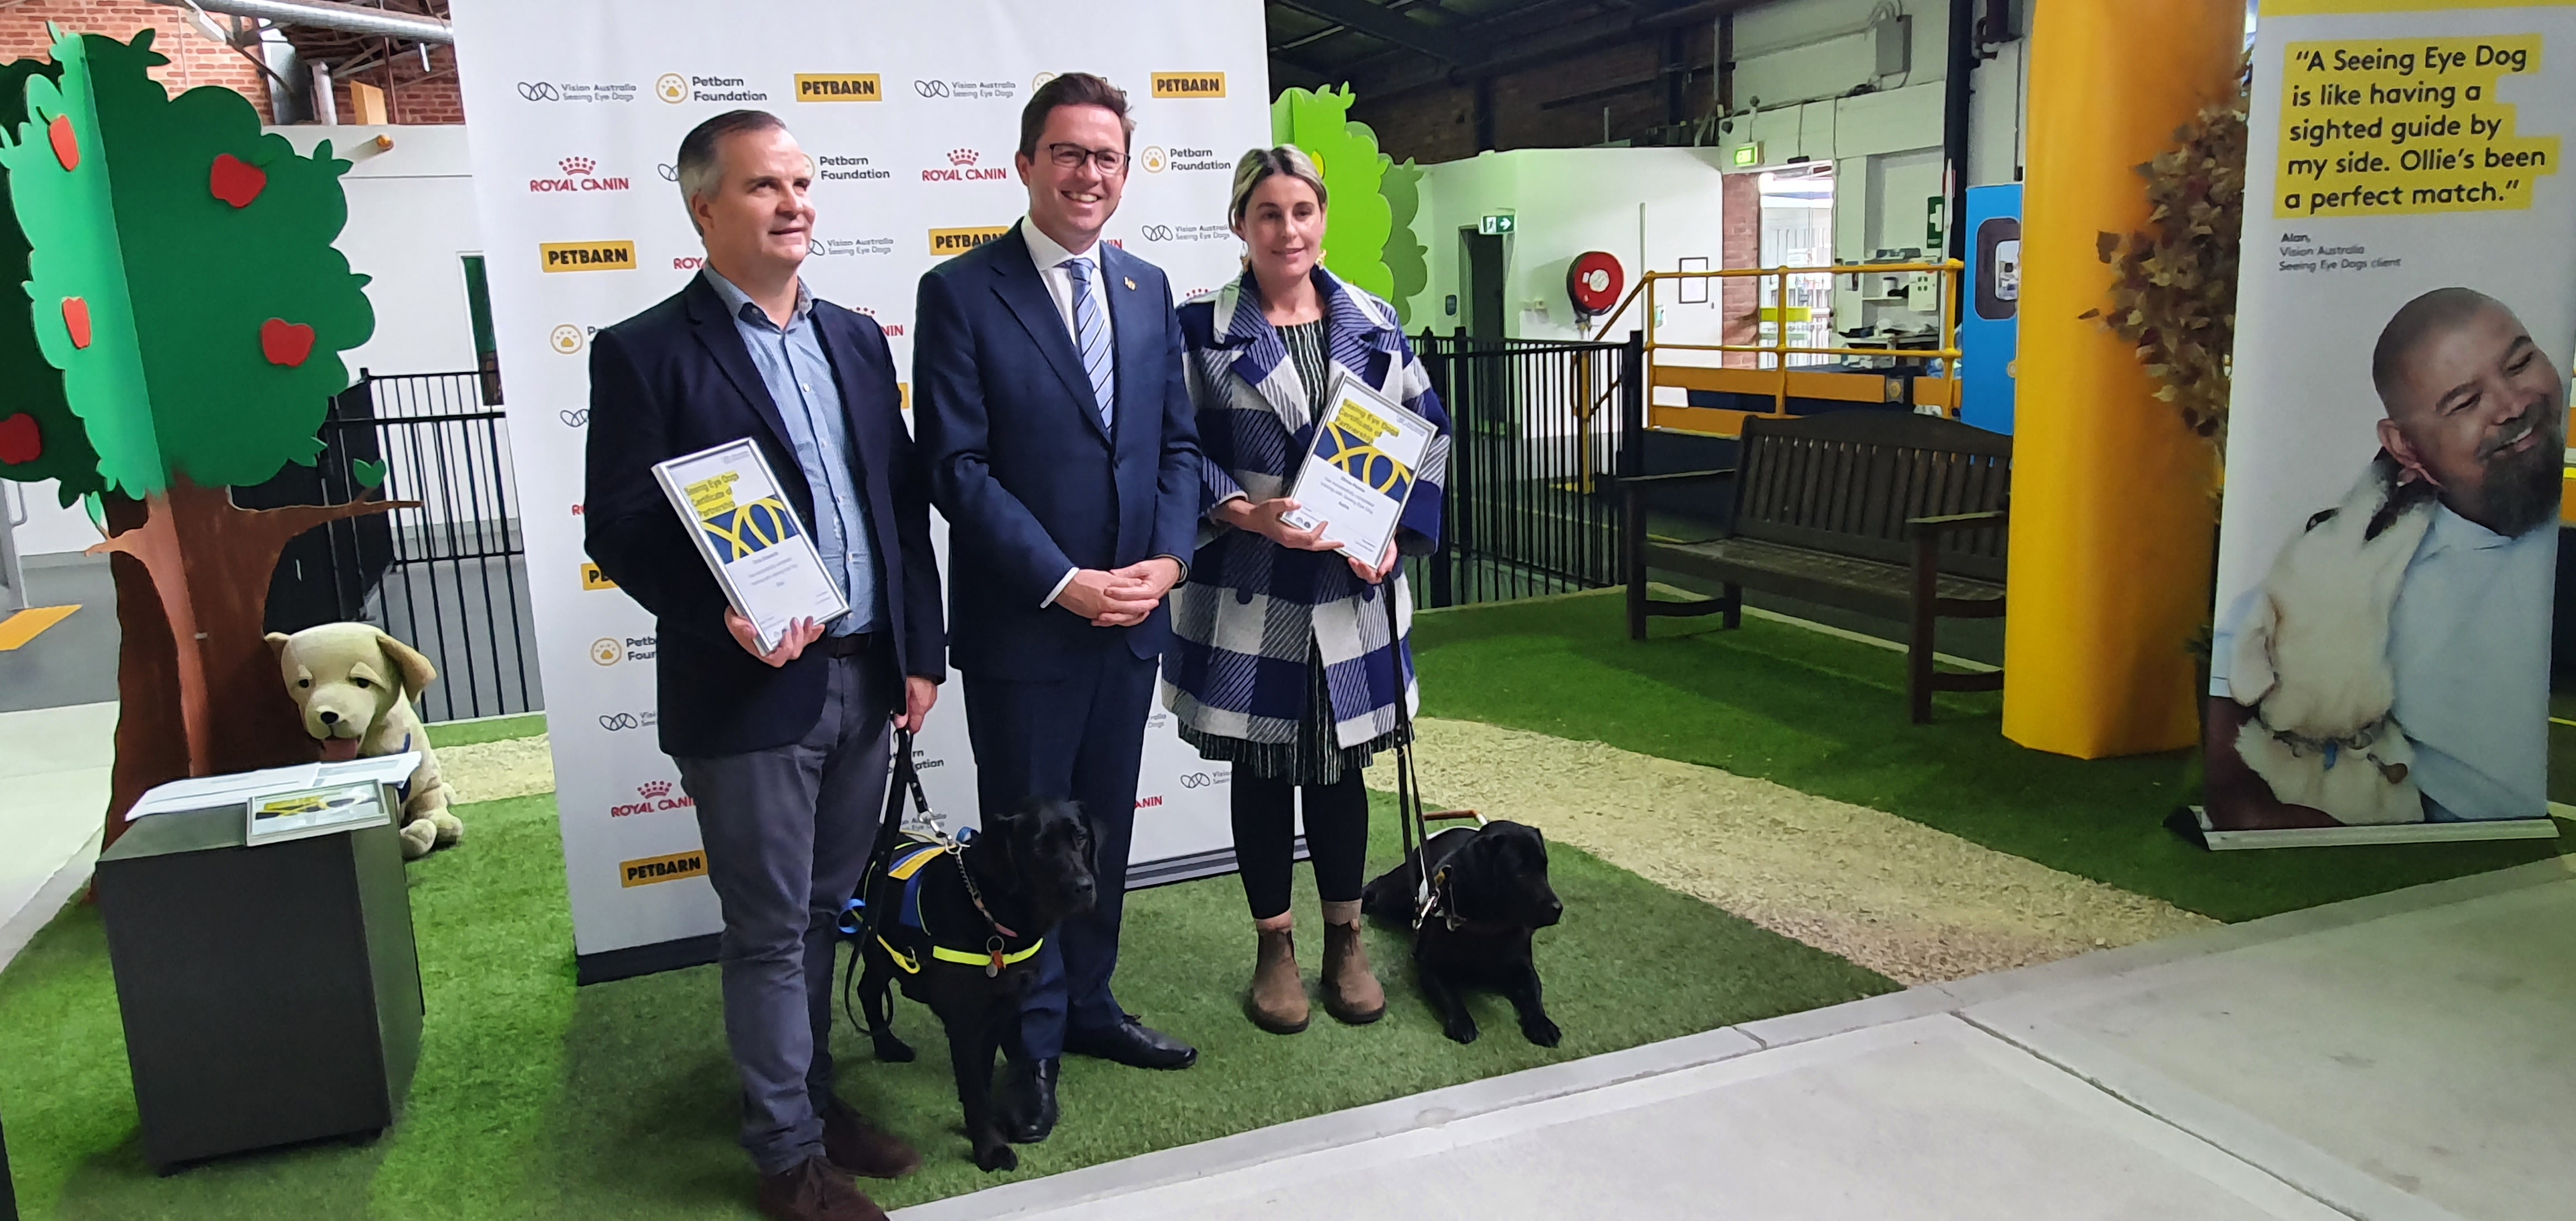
left=912, top=72, right=1200, bottom=1144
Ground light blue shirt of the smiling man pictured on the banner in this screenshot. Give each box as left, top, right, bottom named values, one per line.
left=2210, top=505, right=2558, bottom=822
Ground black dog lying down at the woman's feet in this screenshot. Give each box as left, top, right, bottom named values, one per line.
left=1360, top=819, right=1566, bottom=1048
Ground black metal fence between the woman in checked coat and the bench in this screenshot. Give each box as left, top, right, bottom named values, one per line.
left=1409, top=332, right=1641, bottom=605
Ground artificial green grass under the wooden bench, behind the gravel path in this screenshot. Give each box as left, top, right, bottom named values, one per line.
left=1414, top=590, right=2566, bottom=920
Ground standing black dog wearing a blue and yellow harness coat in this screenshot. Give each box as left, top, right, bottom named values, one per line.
left=858, top=801, right=1095, bottom=1170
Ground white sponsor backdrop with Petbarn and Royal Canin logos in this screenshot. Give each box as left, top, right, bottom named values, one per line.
left=453, top=0, right=1270, bottom=955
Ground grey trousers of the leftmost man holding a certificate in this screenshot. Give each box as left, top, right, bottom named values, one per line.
left=673, top=649, right=902, bottom=1175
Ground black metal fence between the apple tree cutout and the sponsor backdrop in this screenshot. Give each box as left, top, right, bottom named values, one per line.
left=234, top=371, right=543, bottom=721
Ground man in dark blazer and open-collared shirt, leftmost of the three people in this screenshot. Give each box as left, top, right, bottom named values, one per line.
left=582, top=111, right=945, bottom=1221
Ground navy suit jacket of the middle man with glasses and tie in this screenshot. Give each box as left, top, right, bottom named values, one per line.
left=912, top=221, right=1200, bottom=680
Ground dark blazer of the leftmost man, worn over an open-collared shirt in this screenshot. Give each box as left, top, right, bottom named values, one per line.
left=582, top=278, right=948, bottom=758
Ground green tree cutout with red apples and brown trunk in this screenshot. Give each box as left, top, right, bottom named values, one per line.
left=0, top=29, right=394, bottom=840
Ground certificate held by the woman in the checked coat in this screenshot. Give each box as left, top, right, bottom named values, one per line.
left=1283, top=371, right=1440, bottom=567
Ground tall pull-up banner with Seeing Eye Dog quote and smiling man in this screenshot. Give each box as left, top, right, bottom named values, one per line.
left=2200, top=0, right=2576, bottom=848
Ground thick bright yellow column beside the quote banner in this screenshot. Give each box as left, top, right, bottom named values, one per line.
left=2004, top=0, right=2246, bottom=758
